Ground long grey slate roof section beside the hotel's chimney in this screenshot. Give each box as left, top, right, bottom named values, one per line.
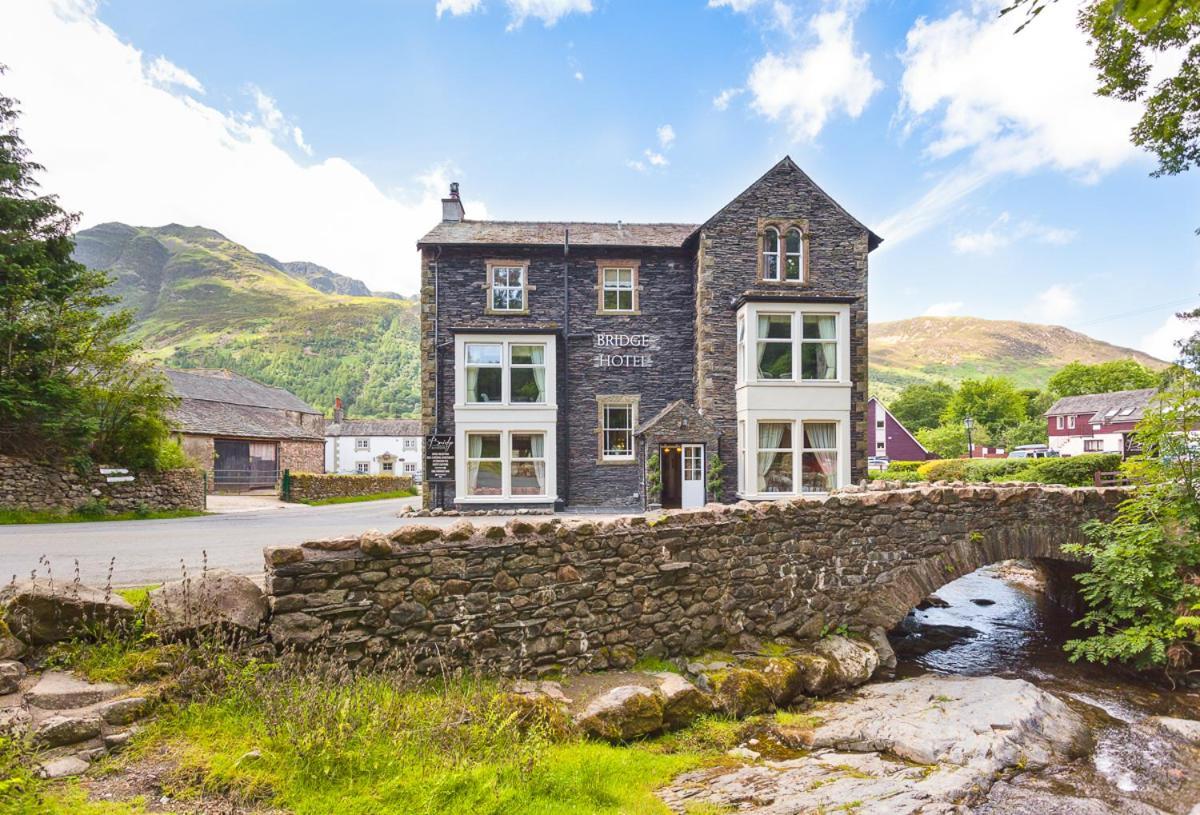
left=416, top=221, right=698, bottom=248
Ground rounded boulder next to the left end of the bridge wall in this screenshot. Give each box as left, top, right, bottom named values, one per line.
left=149, top=569, right=266, bottom=637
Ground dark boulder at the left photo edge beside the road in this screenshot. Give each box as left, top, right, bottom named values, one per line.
left=0, top=580, right=134, bottom=645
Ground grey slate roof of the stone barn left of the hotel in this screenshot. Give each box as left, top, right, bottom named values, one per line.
left=163, top=368, right=323, bottom=441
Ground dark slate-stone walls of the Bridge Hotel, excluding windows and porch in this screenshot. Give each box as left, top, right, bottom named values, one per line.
left=420, top=158, right=878, bottom=509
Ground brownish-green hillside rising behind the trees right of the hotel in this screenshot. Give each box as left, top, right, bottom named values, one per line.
left=870, top=317, right=1166, bottom=401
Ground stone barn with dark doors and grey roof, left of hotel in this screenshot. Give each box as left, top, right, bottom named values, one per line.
left=164, top=368, right=325, bottom=491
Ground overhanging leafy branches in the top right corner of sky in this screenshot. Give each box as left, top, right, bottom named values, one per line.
left=1001, top=0, right=1200, bottom=183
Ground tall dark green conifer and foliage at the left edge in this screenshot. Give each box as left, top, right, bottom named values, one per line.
left=0, top=75, right=169, bottom=466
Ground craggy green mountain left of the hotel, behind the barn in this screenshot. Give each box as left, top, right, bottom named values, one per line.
left=76, top=223, right=420, bottom=417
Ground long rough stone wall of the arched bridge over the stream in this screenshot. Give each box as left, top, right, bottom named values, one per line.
left=265, top=485, right=1126, bottom=675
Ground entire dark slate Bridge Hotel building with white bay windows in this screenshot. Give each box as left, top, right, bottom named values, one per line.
left=418, top=157, right=880, bottom=509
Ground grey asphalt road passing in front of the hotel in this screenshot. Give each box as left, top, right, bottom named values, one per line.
left=0, top=498, right=448, bottom=587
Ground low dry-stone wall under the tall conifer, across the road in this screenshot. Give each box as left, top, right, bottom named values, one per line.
left=0, top=455, right=204, bottom=513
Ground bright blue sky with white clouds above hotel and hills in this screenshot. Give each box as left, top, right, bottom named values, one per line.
left=0, top=0, right=1200, bottom=355
